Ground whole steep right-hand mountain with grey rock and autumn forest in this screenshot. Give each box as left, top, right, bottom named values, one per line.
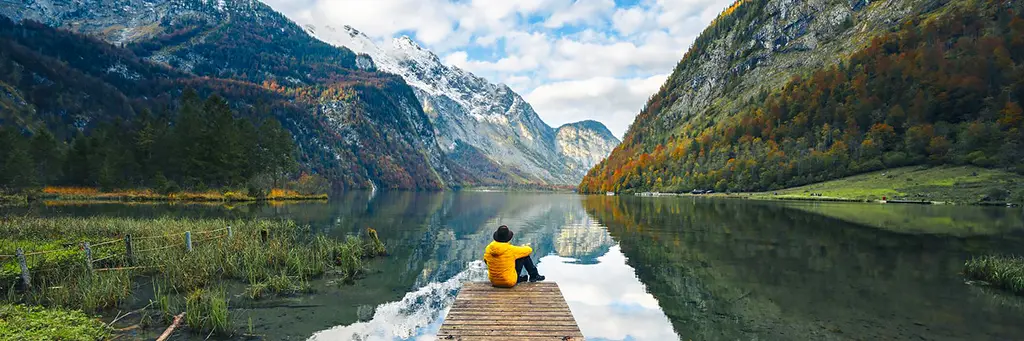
left=580, top=0, right=1024, bottom=193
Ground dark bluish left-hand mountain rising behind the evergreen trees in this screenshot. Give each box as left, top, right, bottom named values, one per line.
left=0, top=0, right=466, bottom=189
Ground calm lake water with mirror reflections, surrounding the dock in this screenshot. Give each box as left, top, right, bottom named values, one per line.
left=18, top=193, right=1024, bottom=340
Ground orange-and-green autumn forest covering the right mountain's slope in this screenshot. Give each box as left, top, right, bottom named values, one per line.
left=580, top=0, right=1024, bottom=193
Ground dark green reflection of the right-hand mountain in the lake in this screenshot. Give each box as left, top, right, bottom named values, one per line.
left=584, top=197, right=1024, bottom=340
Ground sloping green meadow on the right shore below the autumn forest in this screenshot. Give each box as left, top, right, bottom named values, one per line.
left=755, top=166, right=1024, bottom=204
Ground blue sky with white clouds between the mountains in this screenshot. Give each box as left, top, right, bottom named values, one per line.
left=264, top=0, right=733, bottom=138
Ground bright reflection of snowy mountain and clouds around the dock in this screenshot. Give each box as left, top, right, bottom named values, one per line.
left=311, top=194, right=676, bottom=340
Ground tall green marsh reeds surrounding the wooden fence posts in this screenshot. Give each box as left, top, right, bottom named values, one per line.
left=0, top=216, right=384, bottom=334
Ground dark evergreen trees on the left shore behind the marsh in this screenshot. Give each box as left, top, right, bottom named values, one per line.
left=0, top=89, right=298, bottom=195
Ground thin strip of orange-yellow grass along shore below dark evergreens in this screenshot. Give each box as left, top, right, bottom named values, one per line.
left=40, top=186, right=328, bottom=202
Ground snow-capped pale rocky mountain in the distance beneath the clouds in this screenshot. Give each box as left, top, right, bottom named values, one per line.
left=305, top=25, right=618, bottom=184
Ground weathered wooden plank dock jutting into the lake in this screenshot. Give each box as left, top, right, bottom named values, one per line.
left=437, top=282, right=584, bottom=341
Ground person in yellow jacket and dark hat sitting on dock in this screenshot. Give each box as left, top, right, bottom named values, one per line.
left=483, top=225, right=544, bottom=288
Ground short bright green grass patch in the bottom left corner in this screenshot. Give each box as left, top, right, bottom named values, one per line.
left=0, top=303, right=110, bottom=341
